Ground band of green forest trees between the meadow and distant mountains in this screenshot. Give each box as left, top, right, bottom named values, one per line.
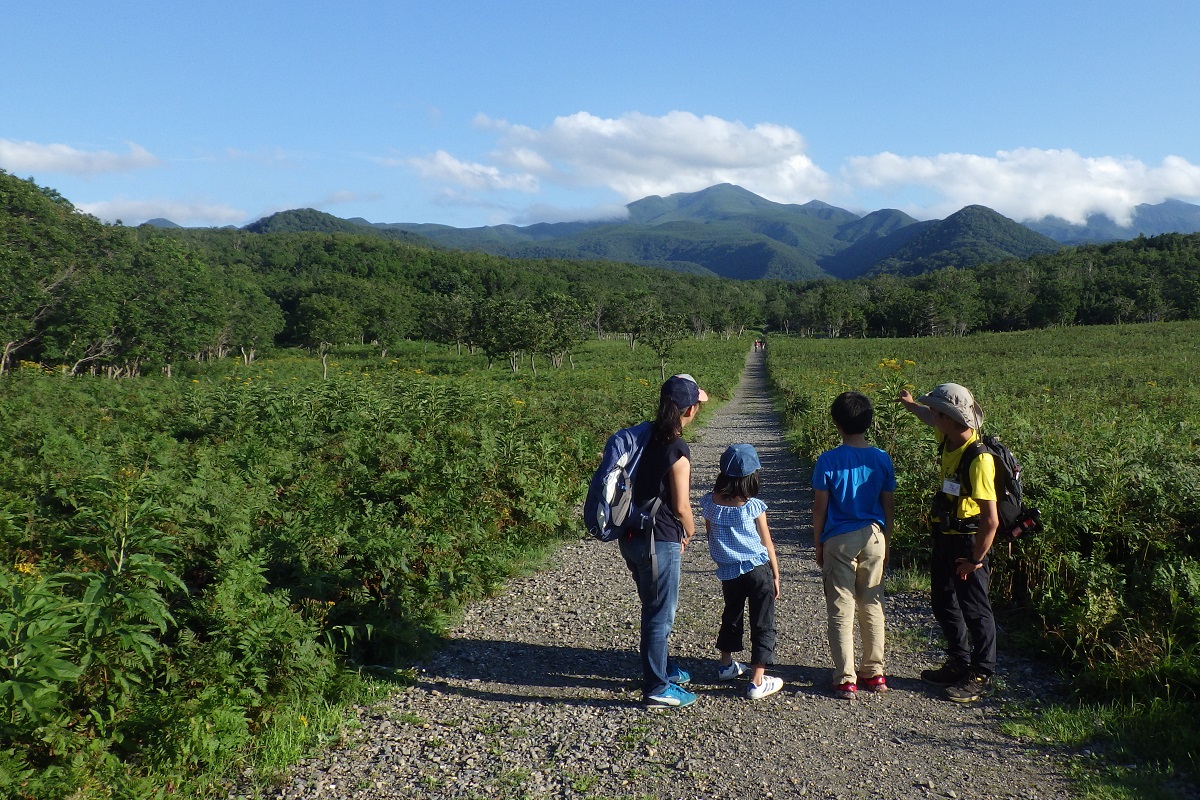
left=0, top=172, right=1200, bottom=375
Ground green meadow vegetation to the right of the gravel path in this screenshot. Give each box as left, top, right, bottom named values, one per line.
left=768, top=321, right=1200, bottom=796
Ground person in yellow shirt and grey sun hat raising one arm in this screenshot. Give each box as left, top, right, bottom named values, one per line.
left=898, top=384, right=1000, bottom=703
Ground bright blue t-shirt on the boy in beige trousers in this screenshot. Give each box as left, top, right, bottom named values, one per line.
left=812, top=445, right=896, bottom=542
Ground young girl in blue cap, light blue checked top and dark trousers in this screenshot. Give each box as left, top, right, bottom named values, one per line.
left=700, top=445, right=784, bottom=700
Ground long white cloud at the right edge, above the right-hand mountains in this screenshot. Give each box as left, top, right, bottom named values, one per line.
left=842, top=148, right=1200, bottom=224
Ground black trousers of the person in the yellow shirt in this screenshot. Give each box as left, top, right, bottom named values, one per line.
left=929, top=530, right=996, bottom=675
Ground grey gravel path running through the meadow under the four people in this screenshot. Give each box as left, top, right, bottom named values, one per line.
left=271, top=353, right=1072, bottom=800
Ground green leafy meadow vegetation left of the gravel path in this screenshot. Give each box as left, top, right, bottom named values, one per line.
left=0, top=337, right=749, bottom=800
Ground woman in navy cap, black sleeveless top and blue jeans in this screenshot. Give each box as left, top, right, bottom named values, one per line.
left=619, top=374, right=708, bottom=708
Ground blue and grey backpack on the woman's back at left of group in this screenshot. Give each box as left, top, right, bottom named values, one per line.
left=583, top=422, right=662, bottom=542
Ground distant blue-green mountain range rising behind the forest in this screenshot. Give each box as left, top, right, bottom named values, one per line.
left=216, top=184, right=1200, bottom=281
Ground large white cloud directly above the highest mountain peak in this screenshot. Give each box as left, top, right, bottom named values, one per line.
left=475, top=112, right=832, bottom=203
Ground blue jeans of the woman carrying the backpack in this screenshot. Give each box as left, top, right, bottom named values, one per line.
left=620, top=536, right=683, bottom=697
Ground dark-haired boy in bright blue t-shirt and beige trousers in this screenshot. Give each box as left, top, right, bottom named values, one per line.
left=812, top=392, right=896, bottom=700
